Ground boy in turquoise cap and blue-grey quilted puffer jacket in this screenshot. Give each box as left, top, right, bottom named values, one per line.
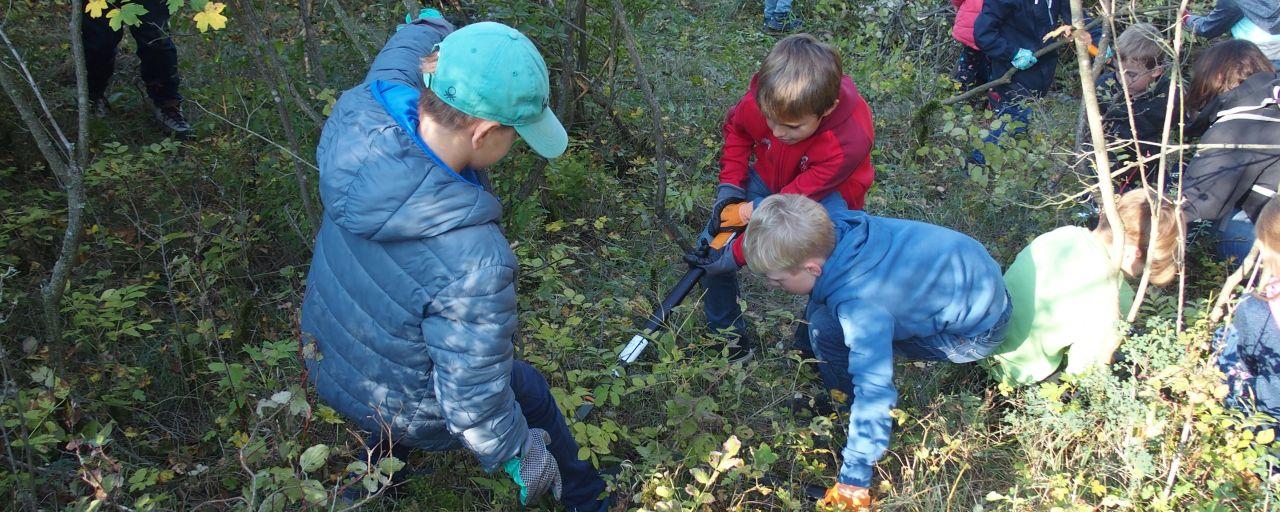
left=302, top=9, right=608, bottom=512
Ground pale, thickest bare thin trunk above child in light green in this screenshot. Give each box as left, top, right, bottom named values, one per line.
left=1071, top=0, right=1124, bottom=259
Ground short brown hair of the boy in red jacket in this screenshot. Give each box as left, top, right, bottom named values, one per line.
left=755, top=33, right=845, bottom=120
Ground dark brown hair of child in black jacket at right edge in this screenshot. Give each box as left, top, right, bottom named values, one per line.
left=1187, top=40, right=1276, bottom=111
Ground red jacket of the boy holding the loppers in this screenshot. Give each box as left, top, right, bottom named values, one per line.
left=719, top=72, right=876, bottom=210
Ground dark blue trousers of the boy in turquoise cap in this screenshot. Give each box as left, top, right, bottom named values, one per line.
left=367, top=361, right=608, bottom=512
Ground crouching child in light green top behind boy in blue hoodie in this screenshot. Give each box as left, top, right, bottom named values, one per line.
left=988, top=189, right=1183, bottom=384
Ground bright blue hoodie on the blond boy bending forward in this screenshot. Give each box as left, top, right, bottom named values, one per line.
left=810, top=211, right=1007, bottom=486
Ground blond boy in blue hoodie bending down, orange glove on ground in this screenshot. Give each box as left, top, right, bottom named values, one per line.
left=742, top=195, right=1011, bottom=507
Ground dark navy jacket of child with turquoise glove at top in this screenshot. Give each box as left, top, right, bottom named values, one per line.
left=973, top=0, right=1071, bottom=96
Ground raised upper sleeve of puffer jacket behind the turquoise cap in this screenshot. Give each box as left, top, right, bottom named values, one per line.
left=365, top=18, right=453, bottom=87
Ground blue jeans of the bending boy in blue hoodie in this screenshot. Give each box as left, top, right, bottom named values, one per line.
left=795, top=293, right=1014, bottom=404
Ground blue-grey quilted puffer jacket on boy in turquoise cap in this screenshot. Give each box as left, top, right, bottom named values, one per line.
left=302, top=19, right=527, bottom=470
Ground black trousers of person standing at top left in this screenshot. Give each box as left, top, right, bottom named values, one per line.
left=82, top=0, right=182, bottom=105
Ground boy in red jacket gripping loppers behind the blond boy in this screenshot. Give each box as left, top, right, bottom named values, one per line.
left=699, top=33, right=876, bottom=361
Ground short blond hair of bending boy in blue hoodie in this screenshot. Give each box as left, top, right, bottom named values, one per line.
left=742, top=193, right=836, bottom=274
